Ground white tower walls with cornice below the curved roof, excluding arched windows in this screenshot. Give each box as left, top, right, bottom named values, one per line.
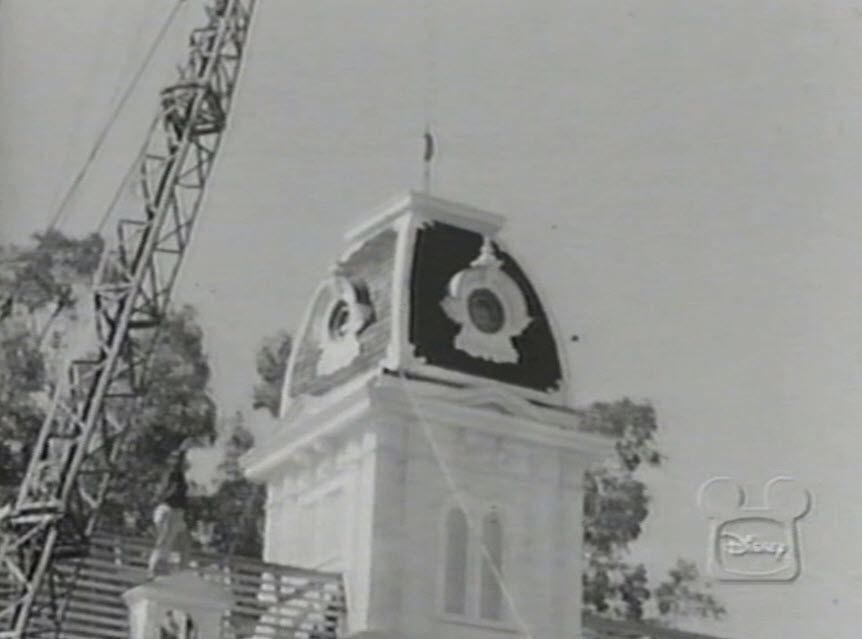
left=249, top=381, right=607, bottom=639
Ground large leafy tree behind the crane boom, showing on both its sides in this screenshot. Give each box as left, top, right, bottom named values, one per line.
left=0, top=231, right=221, bottom=532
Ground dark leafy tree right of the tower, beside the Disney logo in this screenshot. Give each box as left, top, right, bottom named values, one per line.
left=582, top=399, right=726, bottom=625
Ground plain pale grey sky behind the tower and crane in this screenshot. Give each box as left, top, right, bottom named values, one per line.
left=0, top=0, right=862, bottom=639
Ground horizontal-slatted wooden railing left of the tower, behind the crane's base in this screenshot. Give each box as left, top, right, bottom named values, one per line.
left=31, top=533, right=345, bottom=639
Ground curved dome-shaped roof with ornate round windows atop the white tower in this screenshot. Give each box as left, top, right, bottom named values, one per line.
left=282, top=192, right=566, bottom=413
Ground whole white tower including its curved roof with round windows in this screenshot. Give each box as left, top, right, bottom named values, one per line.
left=243, top=193, right=612, bottom=639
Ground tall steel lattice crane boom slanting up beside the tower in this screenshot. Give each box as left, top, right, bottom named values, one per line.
left=0, top=0, right=254, bottom=639
